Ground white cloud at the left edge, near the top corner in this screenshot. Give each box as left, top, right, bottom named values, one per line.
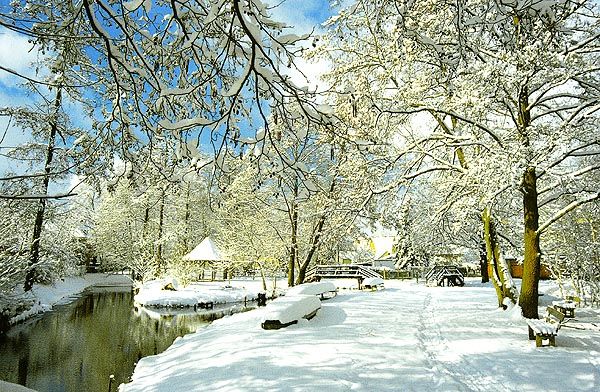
left=0, top=27, right=38, bottom=84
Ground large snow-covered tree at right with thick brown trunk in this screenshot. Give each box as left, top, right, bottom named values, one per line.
left=318, top=0, right=598, bottom=317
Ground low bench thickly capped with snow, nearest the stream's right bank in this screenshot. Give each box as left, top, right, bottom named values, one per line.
left=260, top=295, right=321, bottom=329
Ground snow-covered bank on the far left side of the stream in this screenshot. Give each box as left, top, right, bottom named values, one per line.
left=10, top=273, right=131, bottom=324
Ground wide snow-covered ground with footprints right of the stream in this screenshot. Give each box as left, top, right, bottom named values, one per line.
left=120, top=280, right=600, bottom=392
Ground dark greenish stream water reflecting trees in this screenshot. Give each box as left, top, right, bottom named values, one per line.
left=0, top=288, right=254, bottom=392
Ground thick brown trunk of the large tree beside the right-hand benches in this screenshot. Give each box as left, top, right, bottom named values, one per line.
left=519, top=167, right=540, bottom=318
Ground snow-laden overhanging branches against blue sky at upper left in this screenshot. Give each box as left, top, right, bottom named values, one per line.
left=0, top=0, right=338, bottom=185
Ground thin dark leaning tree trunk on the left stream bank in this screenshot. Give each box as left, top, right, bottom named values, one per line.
left=23, top=86, right=62, bottom=291
